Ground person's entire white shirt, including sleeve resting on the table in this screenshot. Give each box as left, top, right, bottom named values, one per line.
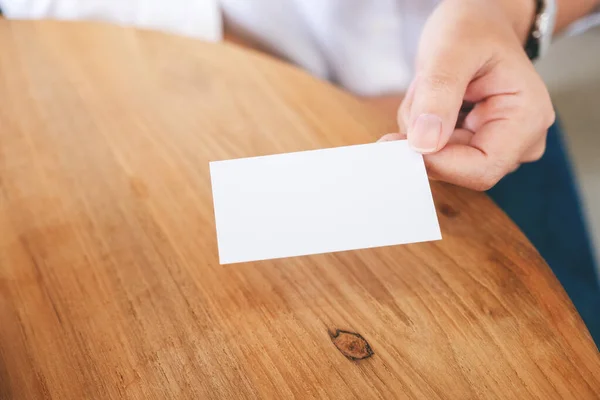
left=0, top=0, right=589, bottom=95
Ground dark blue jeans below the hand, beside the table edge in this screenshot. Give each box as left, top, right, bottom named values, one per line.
left=488, top=123, right=600, bottom=347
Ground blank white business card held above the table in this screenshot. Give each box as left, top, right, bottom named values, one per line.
left=210, top=141, right=441, bottom=264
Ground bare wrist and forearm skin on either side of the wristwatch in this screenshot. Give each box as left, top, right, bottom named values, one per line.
left=496, top=0, right=600, bottom=41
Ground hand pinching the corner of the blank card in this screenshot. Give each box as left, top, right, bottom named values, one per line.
left=384, top=0, right=555, bottom=190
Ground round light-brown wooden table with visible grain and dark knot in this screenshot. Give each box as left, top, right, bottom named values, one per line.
left=0, top=20, right=600, bottom=400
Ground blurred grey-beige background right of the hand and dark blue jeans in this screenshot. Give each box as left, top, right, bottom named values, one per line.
left=537, top=28, right=600, bottom=276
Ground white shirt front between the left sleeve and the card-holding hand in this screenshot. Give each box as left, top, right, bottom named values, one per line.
left=221, top=0, right=439, bottom=95
